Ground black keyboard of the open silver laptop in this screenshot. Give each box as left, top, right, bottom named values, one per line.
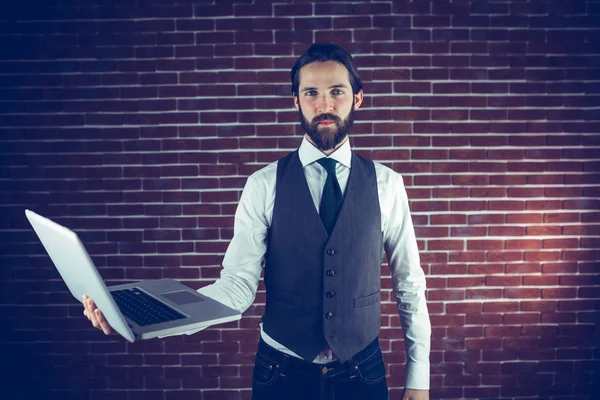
left=110, top=288, right=185, bottom=326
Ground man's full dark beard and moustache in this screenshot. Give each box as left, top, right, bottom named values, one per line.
left=299, top=103, right=354, bottom=151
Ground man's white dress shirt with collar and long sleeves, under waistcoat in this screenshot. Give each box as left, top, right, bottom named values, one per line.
left=198, top=138, right=431, bottom=389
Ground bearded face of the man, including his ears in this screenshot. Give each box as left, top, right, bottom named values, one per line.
left=294, top=61, right=363, bottom=152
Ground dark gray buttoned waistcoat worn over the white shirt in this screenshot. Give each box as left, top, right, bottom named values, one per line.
left=263, top=151, right=383, bottom=362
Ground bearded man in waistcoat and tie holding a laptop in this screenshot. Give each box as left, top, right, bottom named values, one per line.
left=84, top=44, right=431, bottom=400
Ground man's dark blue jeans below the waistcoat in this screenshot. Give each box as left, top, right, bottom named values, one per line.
left=252, top=339, right=388, bottom=400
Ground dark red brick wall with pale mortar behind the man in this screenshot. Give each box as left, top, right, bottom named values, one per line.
left=0, top=0, right=600, bottom=400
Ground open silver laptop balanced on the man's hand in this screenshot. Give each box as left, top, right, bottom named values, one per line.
left=25, top=210, right=241, bottom=342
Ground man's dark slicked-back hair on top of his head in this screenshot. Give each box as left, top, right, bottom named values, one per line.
left=291, top=44, right=362, bottom=96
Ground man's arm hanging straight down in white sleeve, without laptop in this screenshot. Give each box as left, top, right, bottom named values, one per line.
left=382, top=172, right=431, bottom=400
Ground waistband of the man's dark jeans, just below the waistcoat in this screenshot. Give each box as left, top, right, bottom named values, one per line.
left=258, top=337, right=379, bottom=376
